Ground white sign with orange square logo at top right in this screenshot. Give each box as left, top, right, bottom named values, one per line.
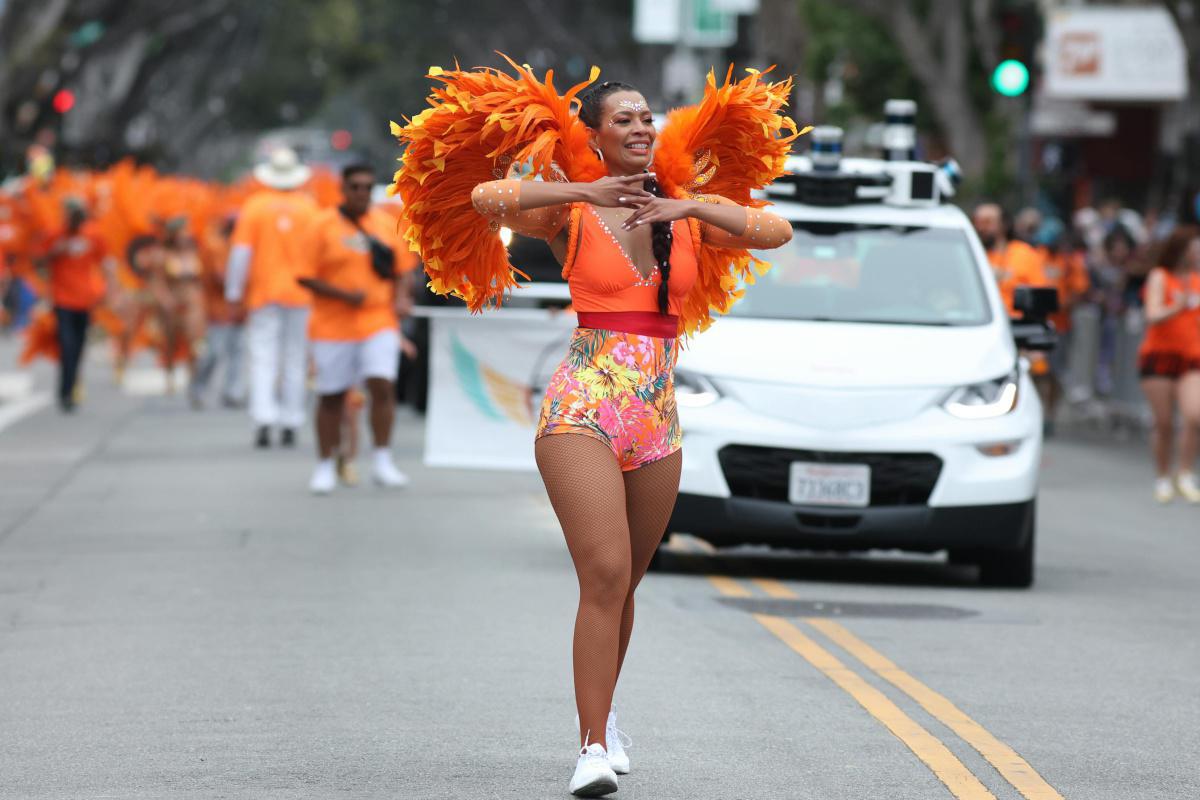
left=1044, top=7, right=1188, bottom=102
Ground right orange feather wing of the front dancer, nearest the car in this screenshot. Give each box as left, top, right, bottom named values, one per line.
left=654, top=66, right=809, bottom=336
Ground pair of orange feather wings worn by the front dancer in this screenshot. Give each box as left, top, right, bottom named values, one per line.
left=391, top=56, right=808, bottom=335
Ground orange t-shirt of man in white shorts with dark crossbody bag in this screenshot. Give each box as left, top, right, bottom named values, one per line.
left=304, top=209, right=403, bottom=342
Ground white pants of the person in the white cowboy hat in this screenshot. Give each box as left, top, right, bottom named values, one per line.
left=246, top=305, right=308, bottom=428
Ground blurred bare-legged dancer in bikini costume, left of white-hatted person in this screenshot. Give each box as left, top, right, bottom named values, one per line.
left=154, top=216, right=204, bottom=404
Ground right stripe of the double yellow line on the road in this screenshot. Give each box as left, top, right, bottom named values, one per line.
left=754, top=578, right=1062, bottom=800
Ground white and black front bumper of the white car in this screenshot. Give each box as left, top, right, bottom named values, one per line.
left=671, top=375, right=1042, bottom=551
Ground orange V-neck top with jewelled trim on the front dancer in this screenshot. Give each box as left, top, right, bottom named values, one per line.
left=563, top=203, right=698, bottom=315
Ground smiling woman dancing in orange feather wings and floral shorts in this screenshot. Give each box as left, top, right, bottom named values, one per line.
left=394, top=61, right=798, bottom=796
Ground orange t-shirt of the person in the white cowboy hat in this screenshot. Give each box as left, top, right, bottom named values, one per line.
left=233, top=190, right=318, bottom=308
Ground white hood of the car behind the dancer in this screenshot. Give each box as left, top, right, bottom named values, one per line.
left=679, top=318, right=1016, bottom=391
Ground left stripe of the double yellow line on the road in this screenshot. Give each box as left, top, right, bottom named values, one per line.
left=708, top=575, right=996, bottom=800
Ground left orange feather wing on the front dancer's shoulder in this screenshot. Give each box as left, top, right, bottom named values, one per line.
left=390, top=56, right=602, bottom=312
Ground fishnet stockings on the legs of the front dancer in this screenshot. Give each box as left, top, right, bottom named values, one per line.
left=534, top=434, right=679, bottom=748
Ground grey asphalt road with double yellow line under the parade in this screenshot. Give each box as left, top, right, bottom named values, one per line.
left=0, top=352, right=1200, bottom=800
